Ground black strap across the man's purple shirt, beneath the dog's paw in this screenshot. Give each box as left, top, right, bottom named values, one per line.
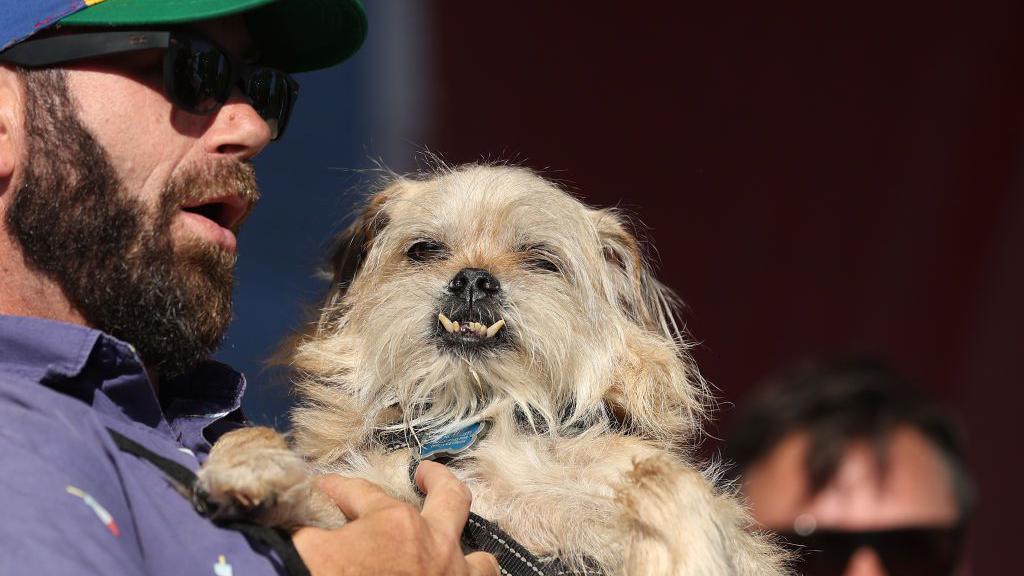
left=106, top=428, right=310, bottom=576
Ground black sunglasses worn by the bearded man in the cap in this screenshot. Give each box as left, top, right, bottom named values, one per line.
left=0, top=31, right=299, bottom=140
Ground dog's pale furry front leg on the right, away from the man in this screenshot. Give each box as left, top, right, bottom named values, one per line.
left=616, top=455, right=787, bottom=576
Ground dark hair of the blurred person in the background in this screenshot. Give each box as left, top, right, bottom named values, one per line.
left=725, top=359, right=974, bottom=520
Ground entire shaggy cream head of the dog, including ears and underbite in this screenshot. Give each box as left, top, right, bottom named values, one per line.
left=291, top=165, right=710, bottom=458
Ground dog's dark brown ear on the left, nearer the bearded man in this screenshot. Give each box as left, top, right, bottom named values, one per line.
left=328, top=186, right=394, bottom=301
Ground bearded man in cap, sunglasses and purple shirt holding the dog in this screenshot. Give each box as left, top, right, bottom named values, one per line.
left=0, top=0, right=497, bottom=576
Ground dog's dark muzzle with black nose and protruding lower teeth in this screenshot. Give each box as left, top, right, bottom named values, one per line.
left=435, top=268, right=508, bottom=348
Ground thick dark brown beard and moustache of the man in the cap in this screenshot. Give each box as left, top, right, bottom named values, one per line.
left=4, top=70, right=259, bottom=377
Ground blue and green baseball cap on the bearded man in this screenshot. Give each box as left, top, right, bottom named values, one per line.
left=0, top=0, right=367, bottom=72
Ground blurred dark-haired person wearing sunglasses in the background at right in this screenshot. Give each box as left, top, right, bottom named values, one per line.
left=726, top=360, right=974, bottom=576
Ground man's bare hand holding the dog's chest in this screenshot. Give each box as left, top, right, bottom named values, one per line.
left=293, top=461, right=500, bottom=576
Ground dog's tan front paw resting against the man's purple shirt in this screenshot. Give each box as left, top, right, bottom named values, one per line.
left=196, top=426, right=345, bottom=529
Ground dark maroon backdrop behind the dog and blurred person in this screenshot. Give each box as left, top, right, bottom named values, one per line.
left=417, top=0, right=1024, bottom=574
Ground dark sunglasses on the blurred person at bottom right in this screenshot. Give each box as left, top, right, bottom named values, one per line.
left=780, top=527, right=963, bottom=576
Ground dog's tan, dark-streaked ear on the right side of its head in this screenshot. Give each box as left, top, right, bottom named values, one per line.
left=592, top=208, right=679, bottom=338
